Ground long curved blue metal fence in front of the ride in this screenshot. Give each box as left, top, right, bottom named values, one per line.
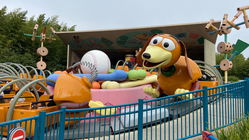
left=0, top=79, right=249, bottom=140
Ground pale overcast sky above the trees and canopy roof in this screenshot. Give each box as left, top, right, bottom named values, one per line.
left=0, top=0, right=249, bottom=57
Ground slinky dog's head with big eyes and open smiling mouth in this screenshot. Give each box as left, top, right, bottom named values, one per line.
left=137, top=34, right=192, bottom=76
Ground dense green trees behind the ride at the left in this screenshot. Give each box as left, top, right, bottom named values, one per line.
left=0, top=7, right=75, bottom=71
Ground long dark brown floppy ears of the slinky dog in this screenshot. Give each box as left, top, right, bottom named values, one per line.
left=136, top=34, right=193, bottom=79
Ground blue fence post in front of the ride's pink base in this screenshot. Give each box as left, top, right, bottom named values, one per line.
left=138, top=99, right=144, bottom=140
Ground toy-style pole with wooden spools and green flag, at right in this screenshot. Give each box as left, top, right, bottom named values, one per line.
left=205, top=6, right=249, bottom=83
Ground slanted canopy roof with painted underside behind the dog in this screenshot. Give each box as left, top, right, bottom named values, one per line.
left=56, top=21, right=220, bottom=51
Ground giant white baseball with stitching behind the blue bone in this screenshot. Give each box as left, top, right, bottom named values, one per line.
left=81, top=50, right=111, bottom=73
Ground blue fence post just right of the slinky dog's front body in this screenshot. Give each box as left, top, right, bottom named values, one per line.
left=203, top=87, right=208, bottom=131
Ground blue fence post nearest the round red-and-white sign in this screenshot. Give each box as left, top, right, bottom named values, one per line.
left=37, top=111, right=46, bottom=140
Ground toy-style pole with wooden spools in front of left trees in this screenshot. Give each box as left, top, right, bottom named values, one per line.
left=24, top=24, right=56, bottom=70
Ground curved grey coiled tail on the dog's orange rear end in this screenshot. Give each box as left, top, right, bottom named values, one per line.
left=66, top=61, right=98, bottom=82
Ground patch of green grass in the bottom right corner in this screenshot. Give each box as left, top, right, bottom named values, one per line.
left=215, top=117, right=249, bottom=140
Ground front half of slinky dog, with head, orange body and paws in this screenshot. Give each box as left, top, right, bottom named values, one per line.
left=137, top=34, right=202, bottom=97
